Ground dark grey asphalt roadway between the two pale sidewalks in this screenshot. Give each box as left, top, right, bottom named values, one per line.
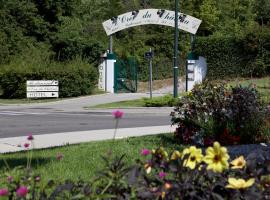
left=0, top=111, right=170, bottom=138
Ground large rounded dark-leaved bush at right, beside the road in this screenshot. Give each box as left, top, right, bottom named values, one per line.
left=171, top=82, right=270, bottom=146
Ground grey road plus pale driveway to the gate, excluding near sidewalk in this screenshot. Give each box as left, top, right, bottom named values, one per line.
left=0, top=91, right=178, bottom=138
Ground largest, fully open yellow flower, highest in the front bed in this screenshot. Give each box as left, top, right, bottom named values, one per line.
left=204, top=142, right=230, bottom=172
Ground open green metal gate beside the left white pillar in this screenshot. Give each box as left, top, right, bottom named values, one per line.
left=114, top=57, right=138, bottom=93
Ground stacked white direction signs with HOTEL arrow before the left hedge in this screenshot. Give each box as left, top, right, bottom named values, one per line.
left=26, top=80, right=59, bottom=98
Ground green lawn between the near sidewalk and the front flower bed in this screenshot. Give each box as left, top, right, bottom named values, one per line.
left=0, top=133, right=180, bottom=184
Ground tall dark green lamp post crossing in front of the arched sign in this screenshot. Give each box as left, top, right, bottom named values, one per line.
left=173, top=0, right=179, bottom=98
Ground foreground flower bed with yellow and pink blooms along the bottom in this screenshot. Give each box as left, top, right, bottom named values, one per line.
left=0, top=133, right=270, bottom=200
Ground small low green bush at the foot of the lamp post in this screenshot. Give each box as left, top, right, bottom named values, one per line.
left=143, top=95, right=176, bottom=107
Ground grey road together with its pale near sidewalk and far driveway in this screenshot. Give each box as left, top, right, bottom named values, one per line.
left=0, top=91, right=178, bottom=153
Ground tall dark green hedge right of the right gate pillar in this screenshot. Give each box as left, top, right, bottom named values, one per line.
left=195, top=30, right=270, bottom=79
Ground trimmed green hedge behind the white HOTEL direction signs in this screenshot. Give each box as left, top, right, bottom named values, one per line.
left=0, top=61, right=98, bottom=98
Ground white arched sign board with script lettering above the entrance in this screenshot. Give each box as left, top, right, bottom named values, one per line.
left=102, top=9, right=202, bottom=35
